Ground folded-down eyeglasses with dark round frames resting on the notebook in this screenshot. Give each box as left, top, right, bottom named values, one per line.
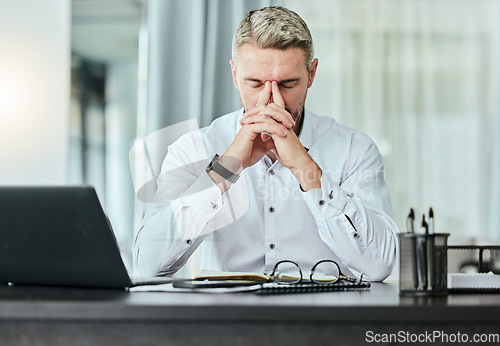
left=269, top=260, right=363, bottom=285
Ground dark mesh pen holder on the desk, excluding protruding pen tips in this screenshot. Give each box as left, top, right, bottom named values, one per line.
left=399, top=233, right=450, bottom=296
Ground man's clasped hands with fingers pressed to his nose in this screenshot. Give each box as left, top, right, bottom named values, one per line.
left=219, top=81, right=321, bottom=191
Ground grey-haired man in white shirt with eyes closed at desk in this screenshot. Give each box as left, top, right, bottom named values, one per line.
left=134, top=7, right=397, bottom=281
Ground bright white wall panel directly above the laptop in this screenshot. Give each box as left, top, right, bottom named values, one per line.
left=0, top=0, right=70, bottom=185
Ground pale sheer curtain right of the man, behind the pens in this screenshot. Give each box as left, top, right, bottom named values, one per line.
left=283, top=0, right=500, bottom=242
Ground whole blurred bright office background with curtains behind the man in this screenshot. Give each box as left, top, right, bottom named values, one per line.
left=0, top=0, right=500, bottom=269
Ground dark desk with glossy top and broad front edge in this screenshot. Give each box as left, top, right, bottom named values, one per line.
left=0, top=284, right=500, bottom=346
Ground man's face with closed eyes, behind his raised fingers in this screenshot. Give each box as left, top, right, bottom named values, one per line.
left=231, top=43, right=318, bottom=121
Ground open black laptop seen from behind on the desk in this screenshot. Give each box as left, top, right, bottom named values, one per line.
left=0, top=186, right=172, bottom=289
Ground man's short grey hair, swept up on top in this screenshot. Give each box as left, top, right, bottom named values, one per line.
left=232, top=6, right=314, bottom=71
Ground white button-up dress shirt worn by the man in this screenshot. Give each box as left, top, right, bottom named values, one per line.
left=134, top=109, right=398, bottom=281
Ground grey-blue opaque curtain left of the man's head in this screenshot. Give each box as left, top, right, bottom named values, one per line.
left=146, top=0, right=281, bottom=133
